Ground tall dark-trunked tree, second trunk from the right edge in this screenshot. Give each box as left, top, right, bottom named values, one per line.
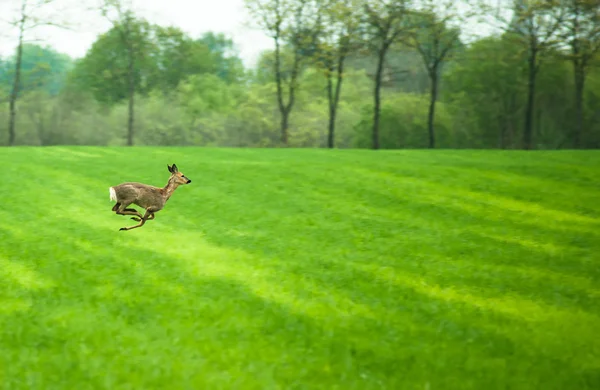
left=483, top=0, right=565, bottom=150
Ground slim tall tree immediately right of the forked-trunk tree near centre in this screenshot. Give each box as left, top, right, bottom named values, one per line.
left=316, top=0, right=362, bottom=148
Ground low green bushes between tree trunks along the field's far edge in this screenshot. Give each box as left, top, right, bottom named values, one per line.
left=8, top=43, right=600, bottom=148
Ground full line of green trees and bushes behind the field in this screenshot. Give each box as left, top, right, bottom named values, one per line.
left=0, top=0, right=600, bottom=149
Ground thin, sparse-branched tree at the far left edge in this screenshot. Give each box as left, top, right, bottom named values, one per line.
left=3, top=0, right=67, bottom=146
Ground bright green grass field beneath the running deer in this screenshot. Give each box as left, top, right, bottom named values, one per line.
left=0, top=147, right=600, bottom=390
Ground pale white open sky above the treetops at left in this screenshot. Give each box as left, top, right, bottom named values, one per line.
left=0, top=0, right=273, bottom=66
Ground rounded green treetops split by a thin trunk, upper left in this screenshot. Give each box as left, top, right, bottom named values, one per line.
left=67, top=19, right=243, bottom=104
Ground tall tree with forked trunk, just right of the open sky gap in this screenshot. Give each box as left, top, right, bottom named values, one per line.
left=246, top=0, right=322, bottom=146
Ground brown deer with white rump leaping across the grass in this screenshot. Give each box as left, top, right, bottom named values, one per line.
left=109, top=164, right=192, bottom=230
